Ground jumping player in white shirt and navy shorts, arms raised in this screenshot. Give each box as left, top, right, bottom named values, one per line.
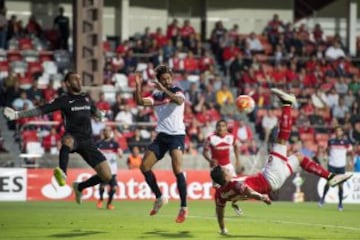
left=135, top=65, right=188, bottom=223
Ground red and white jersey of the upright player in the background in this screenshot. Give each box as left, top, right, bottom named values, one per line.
left=204, top=133, right=236, bottom=166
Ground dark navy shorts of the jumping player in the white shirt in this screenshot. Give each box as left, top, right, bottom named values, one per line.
left=148, top=133, right=185, bottom=160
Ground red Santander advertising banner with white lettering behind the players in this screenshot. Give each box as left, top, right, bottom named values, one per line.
left=27, top=169, right=213, bottom=200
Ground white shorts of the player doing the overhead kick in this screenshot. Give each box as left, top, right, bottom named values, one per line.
left=263, top=144, right=299, bottom=191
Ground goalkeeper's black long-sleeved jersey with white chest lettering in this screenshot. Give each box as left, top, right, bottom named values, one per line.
left=39, top=93, right=97, bottom=140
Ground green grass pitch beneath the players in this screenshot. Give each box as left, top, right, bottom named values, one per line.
left=0, top=201, right=360, bottom=240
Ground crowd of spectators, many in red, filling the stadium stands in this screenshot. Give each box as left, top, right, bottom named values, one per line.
left=0, top=9, right=360, bottom=170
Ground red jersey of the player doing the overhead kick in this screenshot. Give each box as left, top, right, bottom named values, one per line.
left=215, top=173, right=271, bottom=207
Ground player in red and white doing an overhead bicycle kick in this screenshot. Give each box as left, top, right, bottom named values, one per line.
left=211, top=88, right=352, bottom=234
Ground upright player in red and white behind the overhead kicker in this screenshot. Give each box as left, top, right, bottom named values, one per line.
left=203, top=119, right=242, bottom=215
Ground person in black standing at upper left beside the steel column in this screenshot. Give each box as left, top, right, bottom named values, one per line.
left=54, top=7, right=70, bottom=50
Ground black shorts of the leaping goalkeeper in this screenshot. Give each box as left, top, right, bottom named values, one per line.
left=72, top=138, right=106, bottom=168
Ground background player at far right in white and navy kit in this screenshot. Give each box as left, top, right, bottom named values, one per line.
left=319, top=126, right=353, bottom=211
